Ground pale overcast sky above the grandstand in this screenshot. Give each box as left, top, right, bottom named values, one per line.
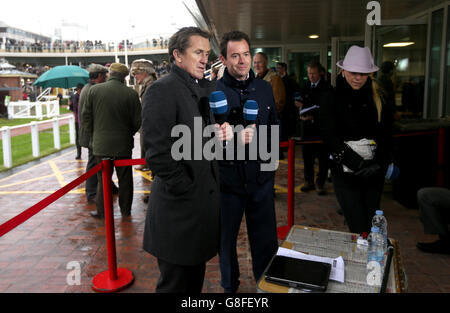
left=0, top=0, right=195, bottom=42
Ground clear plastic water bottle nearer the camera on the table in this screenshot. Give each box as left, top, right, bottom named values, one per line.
left=366, top=226, right=385, bottom=292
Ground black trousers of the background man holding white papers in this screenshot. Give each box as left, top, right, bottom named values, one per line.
left=302, top=144, right=329, bottom=186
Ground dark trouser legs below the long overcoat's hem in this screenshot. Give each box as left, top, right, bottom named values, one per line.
left=156, top=259, right=206, bottom=294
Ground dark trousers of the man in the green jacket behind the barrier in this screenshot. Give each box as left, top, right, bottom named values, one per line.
left=95, top=156, right=133, bottom=215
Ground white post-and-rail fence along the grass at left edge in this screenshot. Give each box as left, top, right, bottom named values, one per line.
left=1, top=114, right=75, bottom=168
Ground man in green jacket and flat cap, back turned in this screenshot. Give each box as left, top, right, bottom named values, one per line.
left=81, top=63, right=141, bottom=218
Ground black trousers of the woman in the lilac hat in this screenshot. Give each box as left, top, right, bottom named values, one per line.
left=332, top=170, right=384, bottom=234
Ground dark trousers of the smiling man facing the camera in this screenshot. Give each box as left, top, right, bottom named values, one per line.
left=219, top=179, right=278, bottom=293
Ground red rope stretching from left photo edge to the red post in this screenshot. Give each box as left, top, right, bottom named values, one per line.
left=0, top=164, right=102, bottom=237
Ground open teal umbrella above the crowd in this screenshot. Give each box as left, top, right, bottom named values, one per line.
left=33, top=65, right=89, bottom=89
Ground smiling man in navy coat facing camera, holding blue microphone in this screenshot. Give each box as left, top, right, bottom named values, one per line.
left=217, top=31, right=279, bottom=293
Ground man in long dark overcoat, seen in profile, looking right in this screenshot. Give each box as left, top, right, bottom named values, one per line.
left=142, top=27, right=231, bottom=293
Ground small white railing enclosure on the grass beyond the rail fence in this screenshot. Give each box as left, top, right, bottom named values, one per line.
left=6, top=100, right=59, bottom=120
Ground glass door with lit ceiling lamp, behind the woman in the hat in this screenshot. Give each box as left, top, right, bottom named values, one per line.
left=369, top=20, right=428, bottom=119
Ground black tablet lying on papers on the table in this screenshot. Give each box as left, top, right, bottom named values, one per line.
left=265, top=255, right=331, bottom=291
